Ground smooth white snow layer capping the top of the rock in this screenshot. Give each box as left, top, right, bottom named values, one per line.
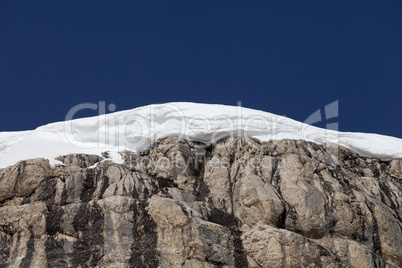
left=0, top=102, right=402, bottom=168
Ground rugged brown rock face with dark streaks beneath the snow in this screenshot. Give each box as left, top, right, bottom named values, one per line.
left=0, top=137, right=402, bottom=267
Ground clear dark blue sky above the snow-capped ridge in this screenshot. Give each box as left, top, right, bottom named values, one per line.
left=0, top=1, right=402, bottom=138
